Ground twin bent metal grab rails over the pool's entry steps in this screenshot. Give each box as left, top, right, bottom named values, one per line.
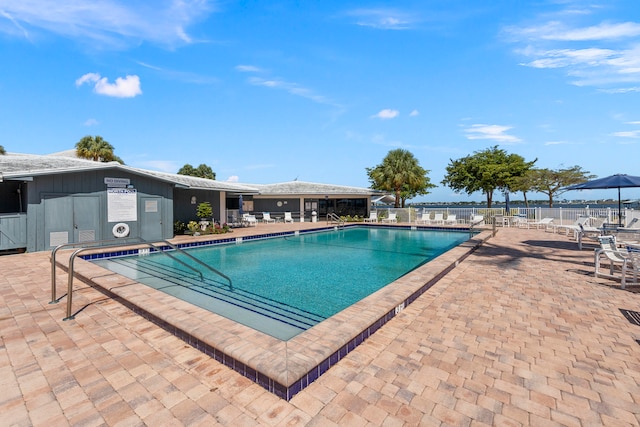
left=49, top=237, right=233, bottom=320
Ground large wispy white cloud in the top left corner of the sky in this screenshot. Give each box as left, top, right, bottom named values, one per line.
left=0, top=0, right=212, bottom=48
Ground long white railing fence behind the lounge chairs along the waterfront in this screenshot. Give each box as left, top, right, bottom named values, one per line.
left=371, top=207, right=640, bottom=225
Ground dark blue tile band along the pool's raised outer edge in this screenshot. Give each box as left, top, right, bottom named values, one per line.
left=70, top=227, right=491, bottom=401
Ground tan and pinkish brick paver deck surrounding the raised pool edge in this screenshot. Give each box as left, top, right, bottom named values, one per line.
left=0, top=224, right=640, bottom=426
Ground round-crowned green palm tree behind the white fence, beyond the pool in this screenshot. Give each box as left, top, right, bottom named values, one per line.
left=366, top=148, right=435, bottom=208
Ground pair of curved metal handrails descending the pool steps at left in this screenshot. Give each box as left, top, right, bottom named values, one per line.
left=51, top=238, right=233, bottom=320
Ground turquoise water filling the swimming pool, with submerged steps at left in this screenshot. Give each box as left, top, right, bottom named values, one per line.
left=93, top=227, right=469, bottom=340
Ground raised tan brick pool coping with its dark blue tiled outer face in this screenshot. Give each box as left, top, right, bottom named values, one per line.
left=59, top=224, right=492, bottom=400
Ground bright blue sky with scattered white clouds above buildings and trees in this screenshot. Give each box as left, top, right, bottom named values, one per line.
left=0, top=0, right=640, bottom=202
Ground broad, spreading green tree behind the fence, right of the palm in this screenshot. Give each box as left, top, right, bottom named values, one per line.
left=442, top=146, right=537, bottom=207
